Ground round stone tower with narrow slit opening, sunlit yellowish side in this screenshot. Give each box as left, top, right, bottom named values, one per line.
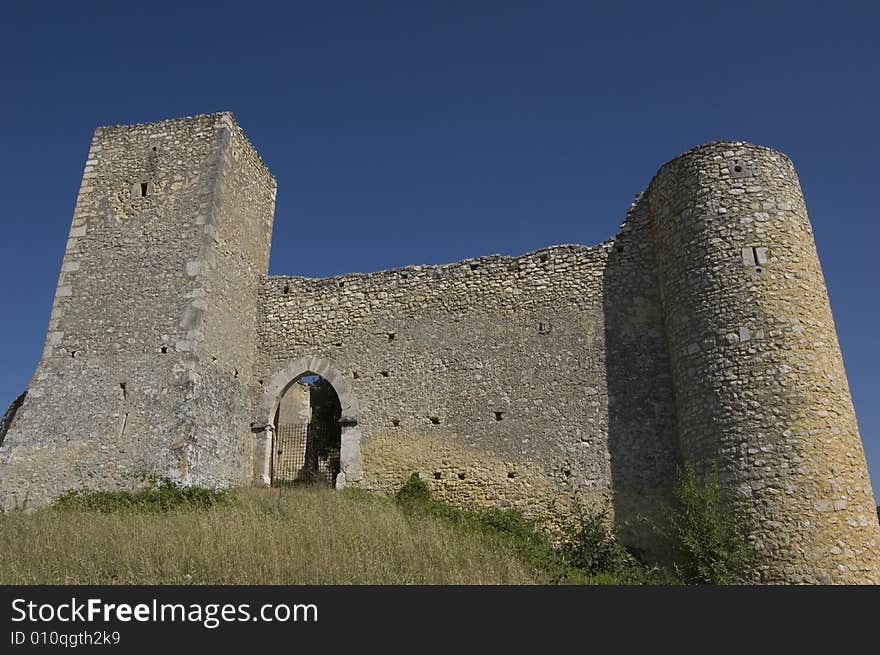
left=646, top=142, right=880, bottom=583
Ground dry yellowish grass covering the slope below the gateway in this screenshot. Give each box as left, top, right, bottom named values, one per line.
left=0, top=489, right=533, bottom=585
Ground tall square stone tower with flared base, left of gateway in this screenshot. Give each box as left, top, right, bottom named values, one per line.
left=0, top=113, right=276, bottom=508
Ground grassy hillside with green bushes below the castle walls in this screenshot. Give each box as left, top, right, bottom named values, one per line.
left=0, top=474, right=735, bottom=585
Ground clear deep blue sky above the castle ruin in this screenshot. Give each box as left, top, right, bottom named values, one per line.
left=0, top=0, right=880, bottom=498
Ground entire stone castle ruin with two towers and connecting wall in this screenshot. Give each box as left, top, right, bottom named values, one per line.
left=0, top=113, right=880, bottom=583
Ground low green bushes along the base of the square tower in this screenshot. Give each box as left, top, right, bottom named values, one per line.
left=52, top=479, right=230, bottom=514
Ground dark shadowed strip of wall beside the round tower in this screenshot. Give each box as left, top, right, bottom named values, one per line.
left=602, top=196, right=679, bottom=558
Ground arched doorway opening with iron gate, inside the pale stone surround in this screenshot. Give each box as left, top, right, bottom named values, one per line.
left=270, top=373, right=342, bottom=487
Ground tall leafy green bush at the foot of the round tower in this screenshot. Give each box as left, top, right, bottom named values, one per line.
left=670, top=466, right=747, bottom=584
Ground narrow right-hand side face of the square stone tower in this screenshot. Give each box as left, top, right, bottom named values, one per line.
left=175, top=114, right=276, bottom=486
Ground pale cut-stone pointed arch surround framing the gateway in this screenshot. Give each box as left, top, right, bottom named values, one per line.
left=258, top=357, right=363, bottom=489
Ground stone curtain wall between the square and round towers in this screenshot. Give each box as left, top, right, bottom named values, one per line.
left=254, top=228, right=674, bottom=536
